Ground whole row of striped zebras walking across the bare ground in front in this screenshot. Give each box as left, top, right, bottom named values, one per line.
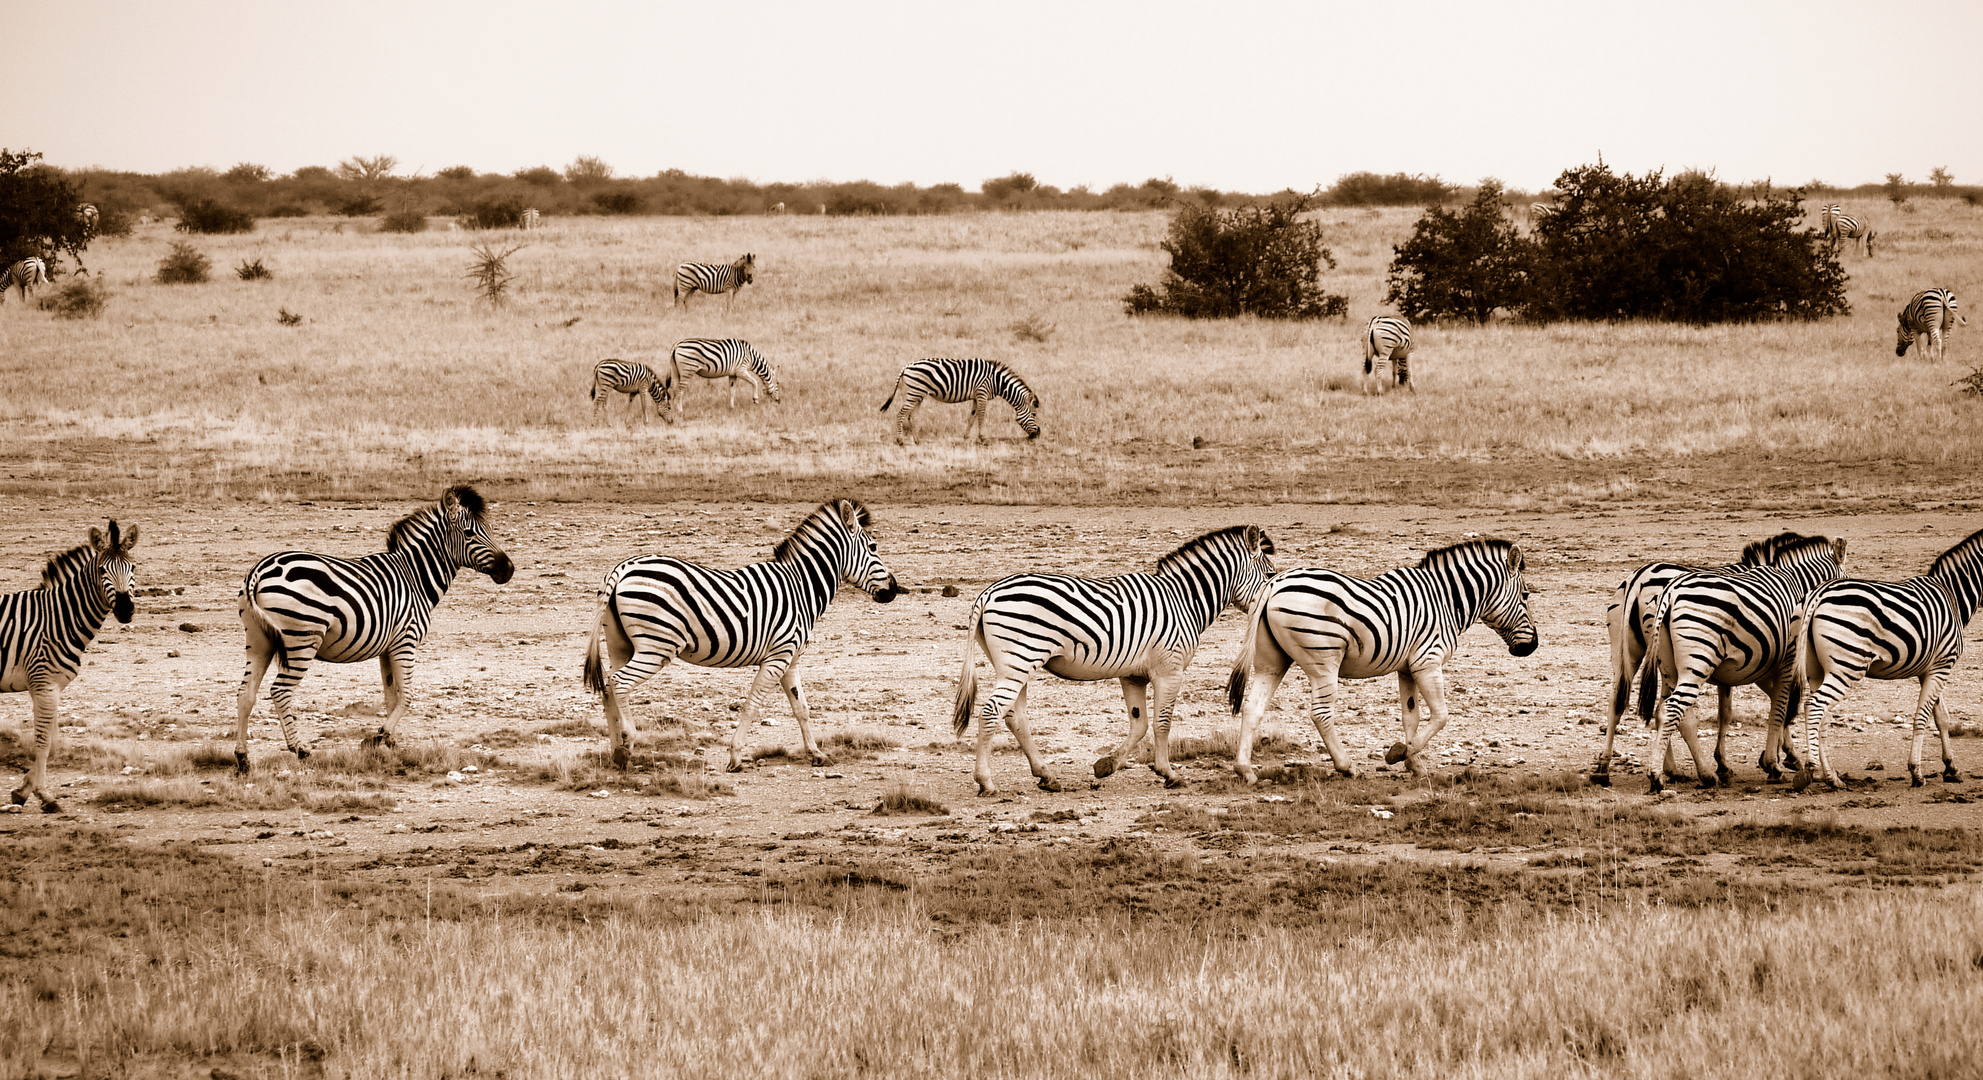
left=0, top=486, right=1983, bottom=812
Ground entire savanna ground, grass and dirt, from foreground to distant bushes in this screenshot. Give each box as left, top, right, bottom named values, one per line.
left=0, top=198, right=1983, bottom=1078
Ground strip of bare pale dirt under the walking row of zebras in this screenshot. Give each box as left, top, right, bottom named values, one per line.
left=0, top=497, right=1983, bottom=892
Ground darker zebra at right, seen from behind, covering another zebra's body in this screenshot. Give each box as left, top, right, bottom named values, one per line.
left=1642, top=533, right=1846, bottom=795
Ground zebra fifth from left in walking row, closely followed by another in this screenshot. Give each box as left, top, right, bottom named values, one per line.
left=1225, top=539, right=1541, bottom=783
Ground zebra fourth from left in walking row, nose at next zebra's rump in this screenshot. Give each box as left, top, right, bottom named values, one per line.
left=952, top=525, right=1273, bottom=795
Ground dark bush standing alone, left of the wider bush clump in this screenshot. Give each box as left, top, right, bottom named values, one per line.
left=1124, top=194, right=1348, bottom=319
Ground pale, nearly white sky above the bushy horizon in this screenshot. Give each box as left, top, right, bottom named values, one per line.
left=15, top=0, right=1983, bottom=192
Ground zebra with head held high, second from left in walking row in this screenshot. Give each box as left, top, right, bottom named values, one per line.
left=234, top=484, right=516, bottom=773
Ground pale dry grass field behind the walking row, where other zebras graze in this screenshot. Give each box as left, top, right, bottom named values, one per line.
left=0, top=200, right=1983, bottom=505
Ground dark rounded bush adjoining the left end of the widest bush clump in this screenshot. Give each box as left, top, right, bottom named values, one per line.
left=1384, top=180, right=1535, bottom=323
